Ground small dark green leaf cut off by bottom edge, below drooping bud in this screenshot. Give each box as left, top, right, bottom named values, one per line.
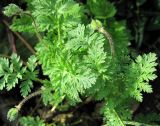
left=19, top=116, right=45, bottom=126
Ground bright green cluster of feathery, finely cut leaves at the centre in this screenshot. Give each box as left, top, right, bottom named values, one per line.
left=36, top=25, right=105, bottom=100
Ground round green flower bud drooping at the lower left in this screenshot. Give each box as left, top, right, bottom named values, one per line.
left=7, top=108, right=18, bottom=121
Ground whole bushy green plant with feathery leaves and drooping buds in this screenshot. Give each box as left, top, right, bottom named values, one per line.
left=0, top=0, right=157, bottom=126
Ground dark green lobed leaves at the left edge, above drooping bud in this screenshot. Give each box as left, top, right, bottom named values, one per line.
left=0, top=54, right=37, bottom=97
